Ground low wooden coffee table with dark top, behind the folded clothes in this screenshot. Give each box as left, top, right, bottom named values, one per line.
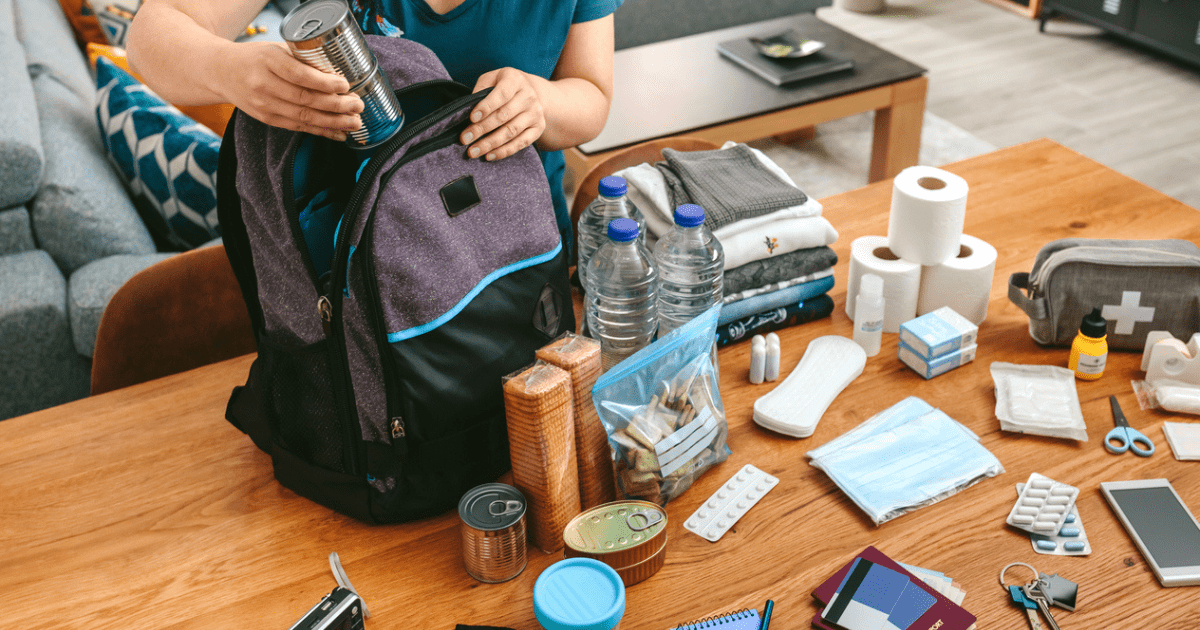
left=564, top=13, right=929, bottom=187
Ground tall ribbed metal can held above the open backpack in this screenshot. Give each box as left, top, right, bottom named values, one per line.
left=280, top=0, right=404, bottom=149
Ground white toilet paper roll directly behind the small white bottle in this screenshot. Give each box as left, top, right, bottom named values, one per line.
left=846, top=236, right=920, bottom=332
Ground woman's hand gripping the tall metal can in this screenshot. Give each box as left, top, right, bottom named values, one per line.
left=214, top=42, right=362, bottom=142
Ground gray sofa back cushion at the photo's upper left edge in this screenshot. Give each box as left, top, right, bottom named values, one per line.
left=0, top=0, right=43, bottom=208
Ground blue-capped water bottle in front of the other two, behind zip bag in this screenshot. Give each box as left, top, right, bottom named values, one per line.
left=584, top=218, right=659, bottom=371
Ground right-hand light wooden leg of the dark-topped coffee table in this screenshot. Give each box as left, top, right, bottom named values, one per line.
left=868, top=77, right=929, bottom=182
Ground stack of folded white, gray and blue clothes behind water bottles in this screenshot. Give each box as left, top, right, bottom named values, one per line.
left=616, top=143, right=838, bottom=346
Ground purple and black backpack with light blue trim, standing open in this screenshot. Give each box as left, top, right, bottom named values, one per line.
left=217, top=36, right=575, bottom=523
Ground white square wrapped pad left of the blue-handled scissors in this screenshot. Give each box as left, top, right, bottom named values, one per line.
left=991, top=361, right=1087, bottom=442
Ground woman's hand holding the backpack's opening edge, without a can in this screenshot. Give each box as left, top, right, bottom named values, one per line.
left=460, top=67, right=546, bottom=161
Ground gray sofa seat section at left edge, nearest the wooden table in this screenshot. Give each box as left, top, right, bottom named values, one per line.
left=0, top=251, right=91, bottom=419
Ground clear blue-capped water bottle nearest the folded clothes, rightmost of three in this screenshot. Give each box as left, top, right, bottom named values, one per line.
left=654, top=204, right=725, bottom=337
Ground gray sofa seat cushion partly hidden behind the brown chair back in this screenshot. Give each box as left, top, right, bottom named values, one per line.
left=67, top=253, right=174, bottom=358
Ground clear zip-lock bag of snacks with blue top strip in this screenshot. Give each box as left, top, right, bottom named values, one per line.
left=592, top=306, right=730, bottom=505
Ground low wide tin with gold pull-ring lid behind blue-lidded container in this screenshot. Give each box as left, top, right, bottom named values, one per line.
left=563, top=500, right=667, bottom=587
